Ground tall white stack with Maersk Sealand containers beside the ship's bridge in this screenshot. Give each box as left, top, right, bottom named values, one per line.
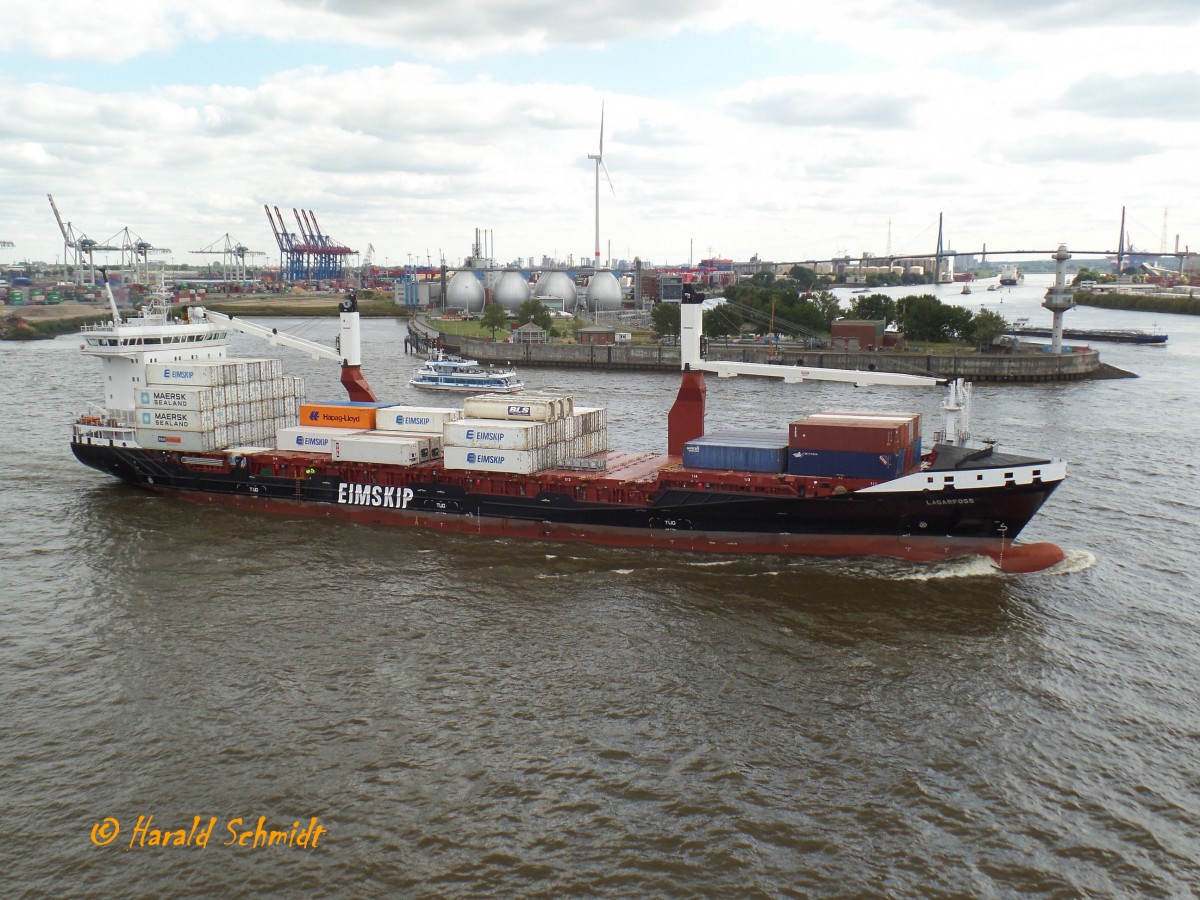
left=134, top=359, right=304, bottom=452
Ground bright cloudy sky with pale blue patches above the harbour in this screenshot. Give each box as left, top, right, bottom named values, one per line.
left=0, top=0, right=1200, bottom=271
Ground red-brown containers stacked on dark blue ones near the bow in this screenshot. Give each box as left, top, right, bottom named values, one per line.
left=787, top=412, right=920, bottom=481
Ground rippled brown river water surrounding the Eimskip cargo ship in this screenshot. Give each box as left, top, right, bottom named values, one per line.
left=0, top=278, right=1200, bottom=898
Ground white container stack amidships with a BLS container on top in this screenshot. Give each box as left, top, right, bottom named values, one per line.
left=443, top=394, right=608, bottom=475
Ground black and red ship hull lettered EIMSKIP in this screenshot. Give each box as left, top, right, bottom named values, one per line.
left=72, top=442, right=1062, bottom=571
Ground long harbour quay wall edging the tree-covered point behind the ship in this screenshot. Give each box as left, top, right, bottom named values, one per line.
left=409, top=319, right=1103, bottom=383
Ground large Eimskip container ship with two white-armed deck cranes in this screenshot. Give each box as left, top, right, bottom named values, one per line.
left=71, top=285, right=1066, bottom=572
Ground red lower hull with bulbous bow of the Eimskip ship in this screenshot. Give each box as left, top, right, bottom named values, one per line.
left=151, top=487, right=1066, bottom=574
